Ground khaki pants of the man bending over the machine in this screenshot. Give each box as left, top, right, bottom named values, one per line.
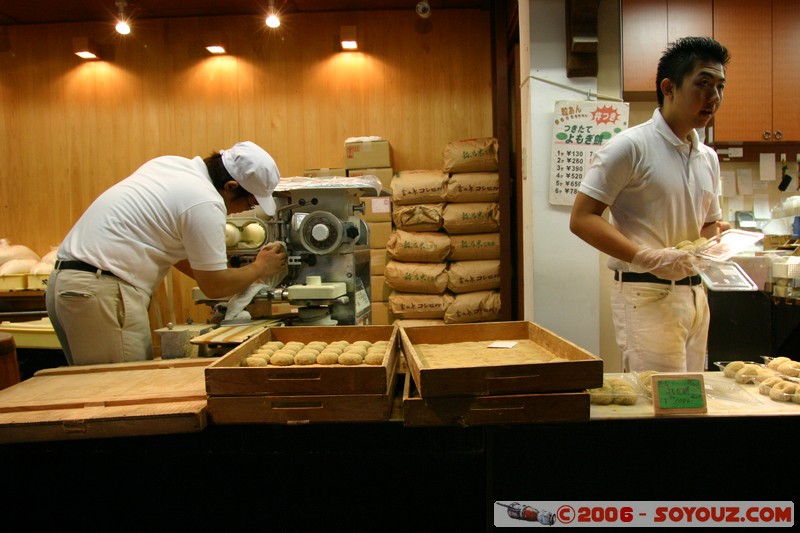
left=45, top=270, right=153, bottom=365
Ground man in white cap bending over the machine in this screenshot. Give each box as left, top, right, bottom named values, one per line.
left=45, top=141, right=286, bottom=365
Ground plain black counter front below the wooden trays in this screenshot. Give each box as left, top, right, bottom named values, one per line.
left=0, top=416, right=798, bottom=531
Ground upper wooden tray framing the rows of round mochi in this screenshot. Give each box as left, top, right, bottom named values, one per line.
left=206, top=326, right=397, bottom=394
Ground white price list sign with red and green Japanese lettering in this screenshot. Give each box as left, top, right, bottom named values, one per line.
left=550, top=100, right=628, bottom=205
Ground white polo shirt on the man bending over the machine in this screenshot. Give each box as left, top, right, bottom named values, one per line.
left=58, top=156, right=227, bottom=294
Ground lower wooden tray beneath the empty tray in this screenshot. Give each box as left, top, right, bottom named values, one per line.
left=403, top=375, right=590, bottom=426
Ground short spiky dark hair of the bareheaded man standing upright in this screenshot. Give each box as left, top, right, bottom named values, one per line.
left=656, top=37, right=730, bottom=107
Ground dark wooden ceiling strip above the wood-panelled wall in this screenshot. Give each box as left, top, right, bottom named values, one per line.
left=0, top=0, right=491, bottom=26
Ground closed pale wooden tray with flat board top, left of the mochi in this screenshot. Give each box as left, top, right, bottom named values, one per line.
left=0, top=359, right=211, bottom=443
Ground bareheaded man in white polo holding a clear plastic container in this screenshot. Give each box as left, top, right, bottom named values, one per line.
left=570, top=37, right=730, bottom=372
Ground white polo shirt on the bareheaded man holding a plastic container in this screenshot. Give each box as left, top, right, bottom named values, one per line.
left=579, top=109, right=722, bottom=270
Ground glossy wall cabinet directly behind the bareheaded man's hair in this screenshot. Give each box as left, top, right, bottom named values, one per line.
left=622, top=0, right=713, bottom=101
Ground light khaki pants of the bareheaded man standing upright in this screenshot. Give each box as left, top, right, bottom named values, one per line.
left=611, top=281, right=710, bottom=372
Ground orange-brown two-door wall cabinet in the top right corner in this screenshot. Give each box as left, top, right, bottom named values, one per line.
left=714, top=0, right=800, bottom=142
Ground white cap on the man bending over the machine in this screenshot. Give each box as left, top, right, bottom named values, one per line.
left=220, top=141, right=281, bottom=216
